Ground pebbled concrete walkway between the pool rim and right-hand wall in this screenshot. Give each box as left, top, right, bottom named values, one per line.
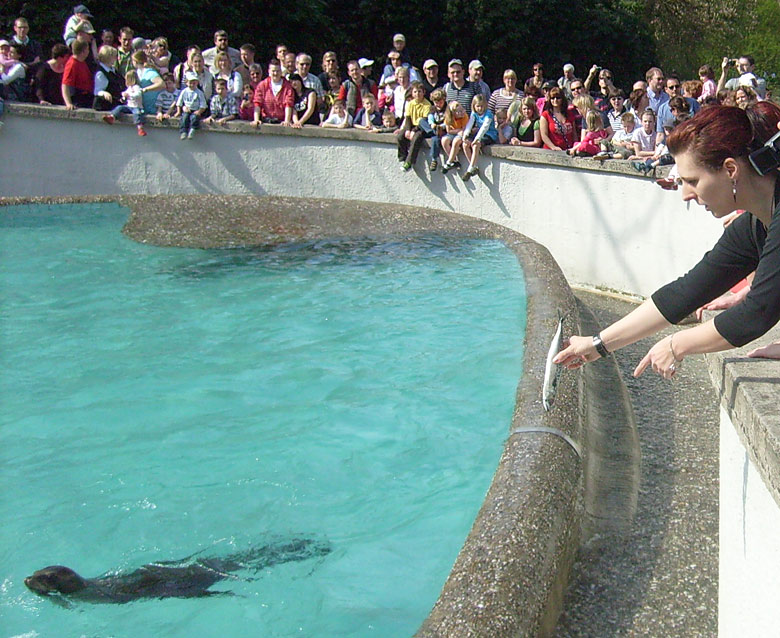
left=553, top=292, right=719, bottom=638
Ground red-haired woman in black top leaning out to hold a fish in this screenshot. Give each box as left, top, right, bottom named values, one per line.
left=554, top=102, right=780, bottom=379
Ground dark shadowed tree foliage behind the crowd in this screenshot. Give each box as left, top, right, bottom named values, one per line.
left=0, top=0, right=655, bottom=86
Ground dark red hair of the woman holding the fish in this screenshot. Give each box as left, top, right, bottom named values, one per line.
left=667, top=102, right=780, bottom=171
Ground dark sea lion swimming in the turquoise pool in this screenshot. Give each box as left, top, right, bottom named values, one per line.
left=24, top=539, right=330, bottom=604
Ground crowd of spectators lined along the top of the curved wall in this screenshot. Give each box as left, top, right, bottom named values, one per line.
left=0, top=5, right=769, bottom=180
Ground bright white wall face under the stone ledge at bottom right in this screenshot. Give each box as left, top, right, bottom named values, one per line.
left=718, top=408, right=780, bottom=638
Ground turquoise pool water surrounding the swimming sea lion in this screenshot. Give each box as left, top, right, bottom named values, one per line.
left=0, top=205, right=525, bottom=638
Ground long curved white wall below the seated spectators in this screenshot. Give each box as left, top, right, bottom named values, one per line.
left=0, top=113, right=722, bottom=296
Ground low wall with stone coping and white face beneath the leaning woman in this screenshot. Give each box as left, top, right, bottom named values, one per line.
left=707, top=326, right=780, bottom=637
